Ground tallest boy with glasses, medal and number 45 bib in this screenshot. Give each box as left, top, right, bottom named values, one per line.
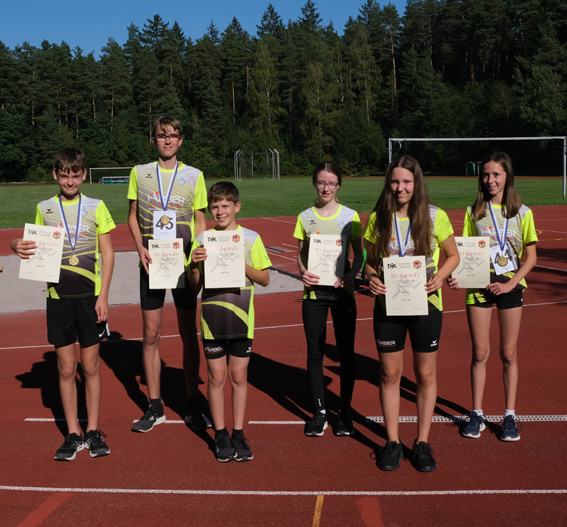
left=128, top=116, right=211, bottom=432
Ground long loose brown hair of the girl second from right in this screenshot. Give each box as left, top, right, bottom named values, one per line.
left=371, top=155, right=433, bottom=261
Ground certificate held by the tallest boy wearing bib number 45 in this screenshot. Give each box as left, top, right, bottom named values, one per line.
left=148, top=238, right=185, bottom=289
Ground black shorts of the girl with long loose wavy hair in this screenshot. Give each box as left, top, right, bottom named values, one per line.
left=374, top=304, right=443, bottom=353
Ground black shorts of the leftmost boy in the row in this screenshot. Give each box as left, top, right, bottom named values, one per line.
left=46, top=296, right=109, bottom=348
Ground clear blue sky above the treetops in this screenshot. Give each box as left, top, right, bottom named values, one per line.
left=0, top=0, right=406, bottom=56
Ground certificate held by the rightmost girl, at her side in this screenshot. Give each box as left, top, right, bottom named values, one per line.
left=452, top=236, right=490, bottom=289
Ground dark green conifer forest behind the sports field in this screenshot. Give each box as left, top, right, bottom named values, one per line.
left=0, top=0, right=567, bottom=181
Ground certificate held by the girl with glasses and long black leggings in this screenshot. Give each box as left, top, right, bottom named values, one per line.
left=308, top=234, right=346, bottom=286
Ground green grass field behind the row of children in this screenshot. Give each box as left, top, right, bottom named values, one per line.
left=0, top=177, right=567, bottom=229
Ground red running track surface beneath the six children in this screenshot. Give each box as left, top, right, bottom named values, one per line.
left=0, top=207, right=567, bottom=526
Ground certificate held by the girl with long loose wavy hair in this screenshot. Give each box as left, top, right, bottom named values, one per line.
left=383, top=256, right=428, bottom=316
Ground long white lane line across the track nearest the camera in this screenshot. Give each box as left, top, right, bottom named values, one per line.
left=0, top=485, right=567, bottom=496
